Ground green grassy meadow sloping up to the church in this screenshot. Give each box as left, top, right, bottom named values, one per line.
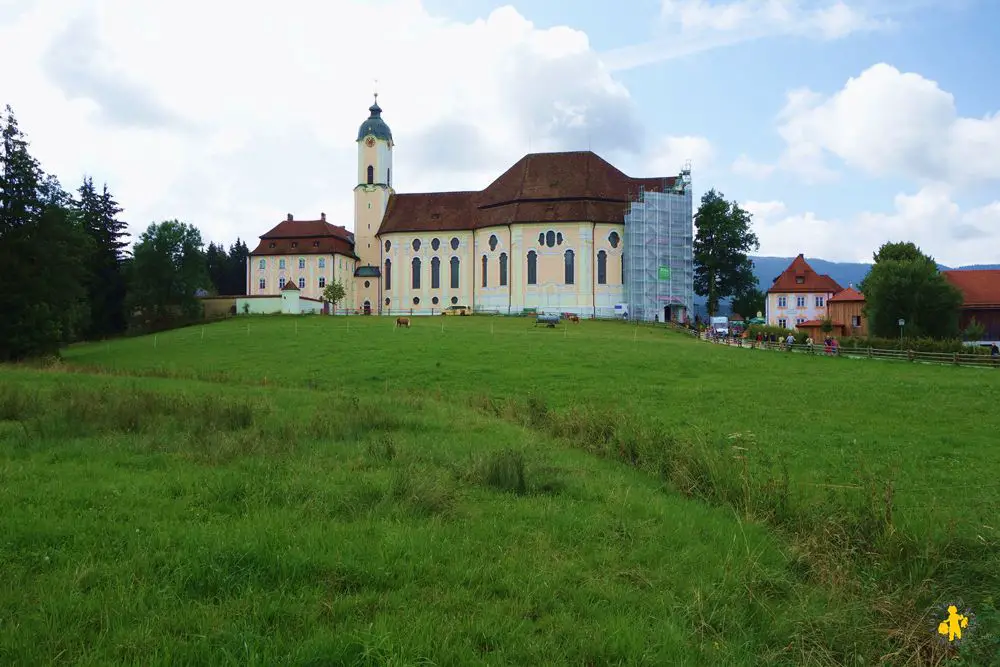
left=0, top=316, right=1000, bottom=665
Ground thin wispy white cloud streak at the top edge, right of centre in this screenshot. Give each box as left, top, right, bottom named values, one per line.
left=605, top=0, right=904, bottom=70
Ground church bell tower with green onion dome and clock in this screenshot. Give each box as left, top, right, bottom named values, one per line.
left=354, top=93, right=393, bottom=313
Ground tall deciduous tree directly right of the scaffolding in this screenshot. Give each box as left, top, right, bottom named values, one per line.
left=694, top=189, right=760, bottom=316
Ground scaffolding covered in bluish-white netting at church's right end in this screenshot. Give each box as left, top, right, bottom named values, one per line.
left=624, top=164, right=694, bottom=322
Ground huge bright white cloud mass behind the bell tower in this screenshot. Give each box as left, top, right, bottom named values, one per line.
left=0, top=0, right=712, bottom=248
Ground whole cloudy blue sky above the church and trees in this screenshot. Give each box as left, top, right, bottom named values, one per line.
left=0, top=0, right=1000, bottom=266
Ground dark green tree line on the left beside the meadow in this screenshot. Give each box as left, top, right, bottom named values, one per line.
left=0, top=105, right=249, bottom=361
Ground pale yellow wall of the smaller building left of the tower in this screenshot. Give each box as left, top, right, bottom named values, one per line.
left=247, top=253, right=355, bottom=307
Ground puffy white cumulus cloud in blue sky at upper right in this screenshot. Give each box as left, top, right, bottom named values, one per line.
left=779, top=63, right=1000, bottom=186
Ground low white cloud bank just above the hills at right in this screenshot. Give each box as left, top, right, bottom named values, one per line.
left=742, top=185, right=1000, bottom=266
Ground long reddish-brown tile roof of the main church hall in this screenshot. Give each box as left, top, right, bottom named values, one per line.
left=378, top=151, right=675, bottom=234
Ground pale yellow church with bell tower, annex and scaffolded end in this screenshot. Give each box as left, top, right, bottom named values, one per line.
left=242, top=94, right=694, bottom=321
